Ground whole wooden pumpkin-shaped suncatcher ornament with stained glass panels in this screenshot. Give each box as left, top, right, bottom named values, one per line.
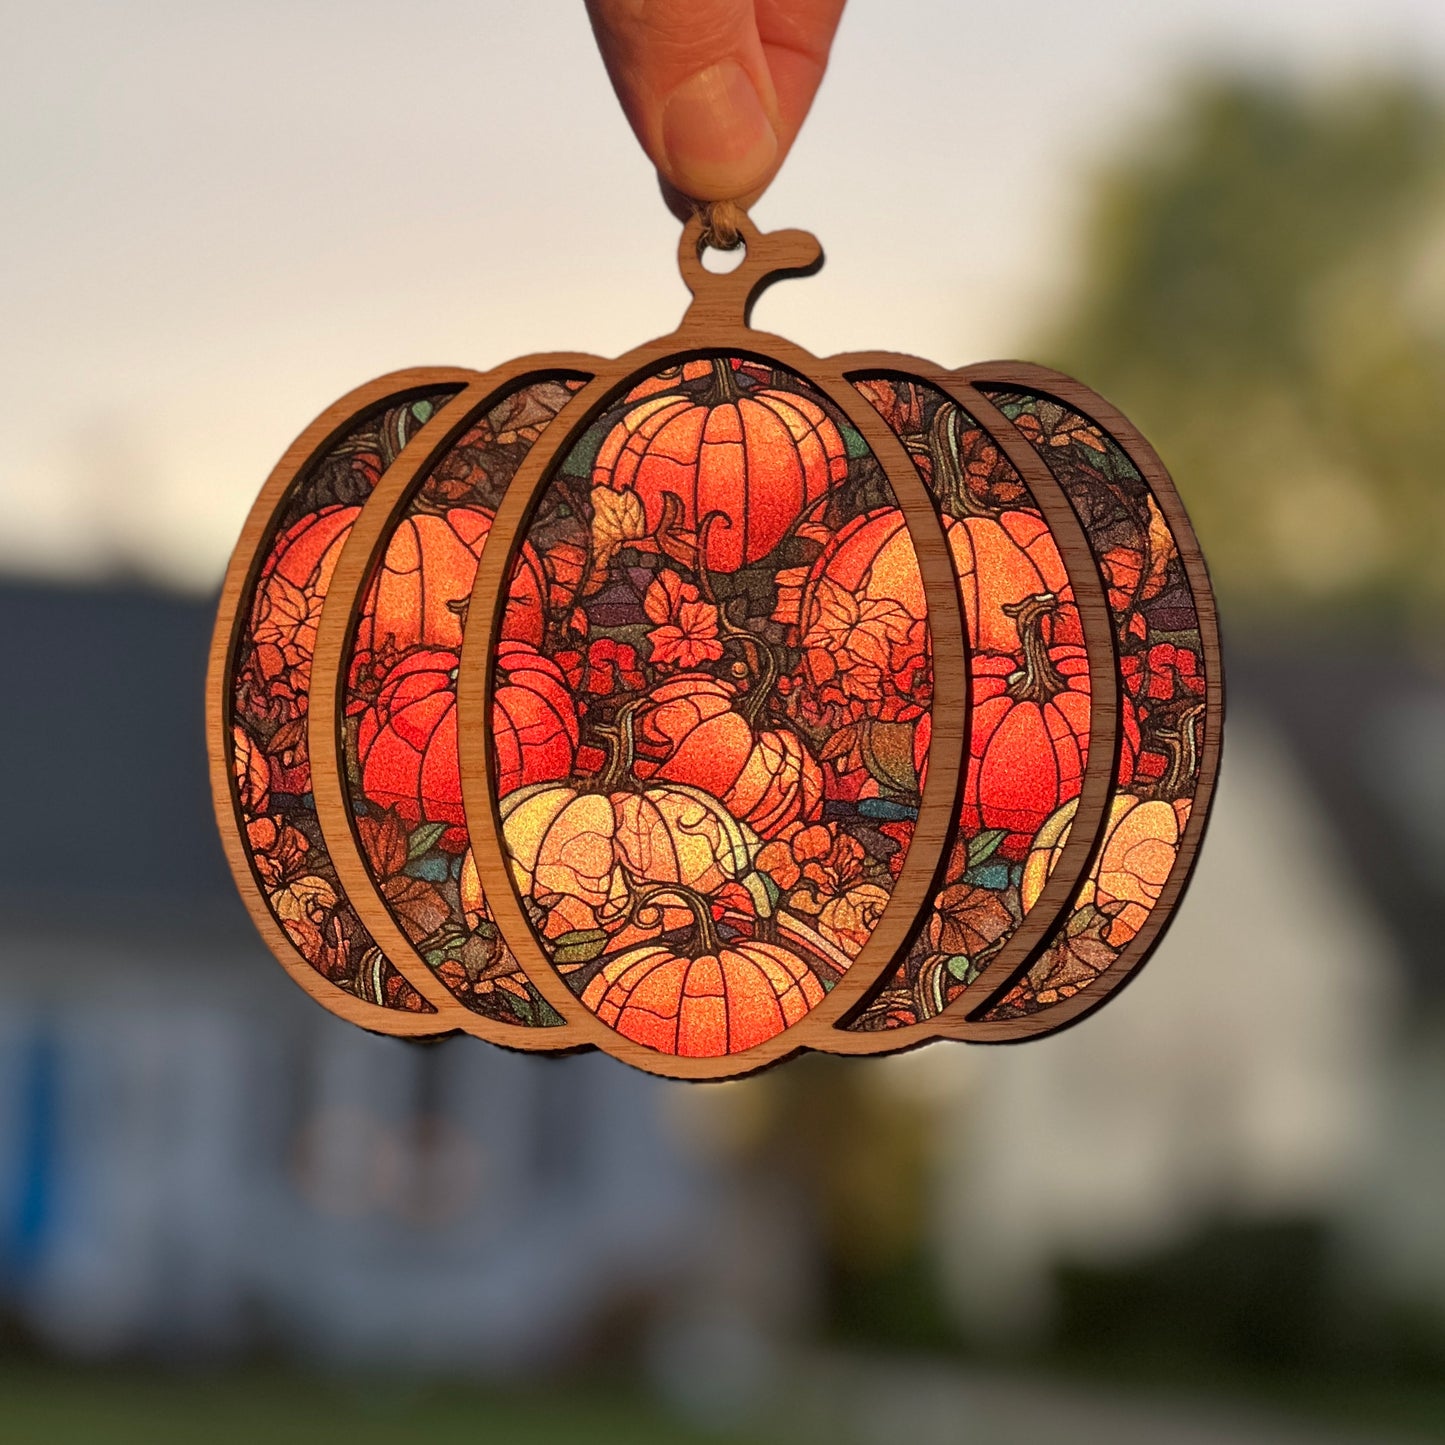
left=208, top=209, right=1222, bottom=1078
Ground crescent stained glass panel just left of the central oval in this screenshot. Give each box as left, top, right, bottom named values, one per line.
left=342, top=376, right=584, bottom=1026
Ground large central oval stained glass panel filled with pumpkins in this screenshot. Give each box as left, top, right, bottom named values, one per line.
left=493, top=357, right=933, bottom=1058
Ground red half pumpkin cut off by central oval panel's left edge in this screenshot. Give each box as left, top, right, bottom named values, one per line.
left=491, top=639, right=579, bottom=798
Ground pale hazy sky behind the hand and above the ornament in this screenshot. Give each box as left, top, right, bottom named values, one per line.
left=8, top=0, right=1445, bottom=591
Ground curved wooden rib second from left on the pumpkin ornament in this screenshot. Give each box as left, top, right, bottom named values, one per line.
left=306, top=353, right=604, bottom=1052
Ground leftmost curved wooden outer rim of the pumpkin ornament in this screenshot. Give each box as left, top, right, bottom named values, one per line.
left=205, top=367, right=477, bottom=1038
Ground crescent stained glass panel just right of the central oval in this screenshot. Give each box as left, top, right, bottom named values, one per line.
left=853, top=376, right=1091, bottom=1032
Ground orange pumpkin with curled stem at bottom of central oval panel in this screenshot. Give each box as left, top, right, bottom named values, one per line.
left=582, top=886, right=824, bottom=1059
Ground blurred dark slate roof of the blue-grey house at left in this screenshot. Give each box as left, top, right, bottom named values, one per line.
left=0, top=581, right=240, bottom=915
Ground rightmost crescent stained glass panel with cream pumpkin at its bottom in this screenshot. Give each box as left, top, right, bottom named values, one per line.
left=984, top=387, right=1205, bottom=1019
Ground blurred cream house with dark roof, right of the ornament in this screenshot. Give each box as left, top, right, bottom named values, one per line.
left=897, top=640, right=1445, bottom=1340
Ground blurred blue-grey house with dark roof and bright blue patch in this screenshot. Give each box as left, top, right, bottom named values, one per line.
left=0, top=572, right=736, bottom=1373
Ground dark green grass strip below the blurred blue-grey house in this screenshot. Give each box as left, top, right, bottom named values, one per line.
left=0, top=1361, right=770, bottom=1445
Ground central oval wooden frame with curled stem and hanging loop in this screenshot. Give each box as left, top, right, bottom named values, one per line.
left=457, top=210, right=967, bottom=1079
